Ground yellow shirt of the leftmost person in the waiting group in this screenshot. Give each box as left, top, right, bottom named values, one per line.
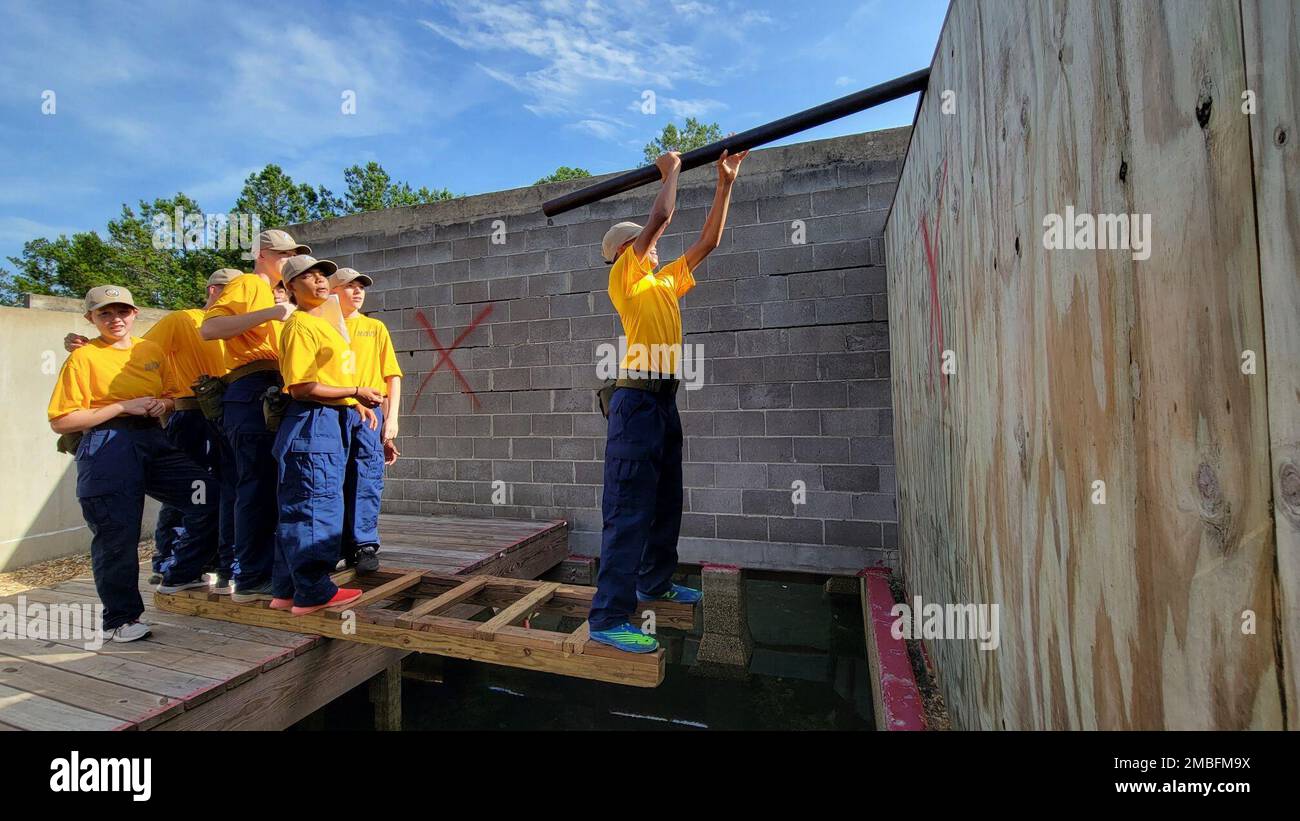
left=47, top=336, right=168, bottom=421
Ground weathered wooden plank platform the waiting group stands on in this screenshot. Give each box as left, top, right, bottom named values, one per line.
left=0, top=516, right=568, bottom=730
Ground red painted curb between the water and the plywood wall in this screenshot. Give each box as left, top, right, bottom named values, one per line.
left=858, top=568, right=926, bottom=730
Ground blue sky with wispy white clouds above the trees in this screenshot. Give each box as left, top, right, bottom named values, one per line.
left=0, top=0, right=946, bottom=262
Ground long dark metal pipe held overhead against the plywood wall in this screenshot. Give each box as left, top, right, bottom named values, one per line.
left=542, top=69, right=930, bottom=217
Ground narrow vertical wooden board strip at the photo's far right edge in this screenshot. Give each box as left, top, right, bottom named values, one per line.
left=1242, top=0, right=1300, bottom=730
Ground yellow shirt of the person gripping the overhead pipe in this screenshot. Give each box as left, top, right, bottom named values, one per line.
left=610, top=246, right=696, bottom=375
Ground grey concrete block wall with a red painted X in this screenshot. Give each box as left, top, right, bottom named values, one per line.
left=290, top=129, right=910, bottom=572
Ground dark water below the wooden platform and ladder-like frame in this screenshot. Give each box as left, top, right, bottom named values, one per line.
left=294, top=574, right=874, bottom=730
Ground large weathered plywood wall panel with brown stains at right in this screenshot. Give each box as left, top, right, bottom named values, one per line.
left=885, top=0, right=1300, bottom=729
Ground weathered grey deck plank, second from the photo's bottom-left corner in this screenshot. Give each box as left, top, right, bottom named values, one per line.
left=0, top=657, right=185, bottom=730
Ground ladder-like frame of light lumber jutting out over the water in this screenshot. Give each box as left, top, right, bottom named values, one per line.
left=153, top=568, right=696, bottom=687
